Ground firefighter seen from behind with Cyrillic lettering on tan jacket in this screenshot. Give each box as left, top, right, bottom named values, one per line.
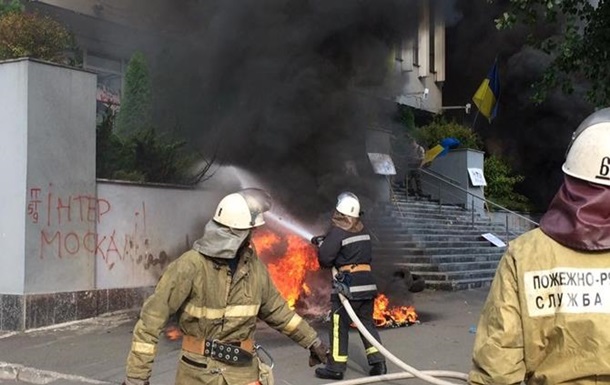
left=469, top=108, right=610, bottom=384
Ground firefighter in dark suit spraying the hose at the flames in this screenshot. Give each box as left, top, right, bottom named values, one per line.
left=312, top=192, right=387, bottom=380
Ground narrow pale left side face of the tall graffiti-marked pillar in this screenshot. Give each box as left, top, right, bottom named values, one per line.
left=0, top=61, right=28, bottom=294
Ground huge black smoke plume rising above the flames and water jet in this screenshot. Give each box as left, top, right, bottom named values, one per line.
left=145, top=0, right=452, bottom=219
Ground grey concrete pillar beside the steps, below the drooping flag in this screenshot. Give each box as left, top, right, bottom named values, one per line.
left=422, top=149, right=485, bottom=213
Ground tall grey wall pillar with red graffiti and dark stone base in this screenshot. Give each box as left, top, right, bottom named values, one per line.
left=0, top=58, right=100, bottom=330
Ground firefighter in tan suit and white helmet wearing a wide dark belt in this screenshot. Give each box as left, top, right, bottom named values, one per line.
left=124, top=189, right=328, bottom=385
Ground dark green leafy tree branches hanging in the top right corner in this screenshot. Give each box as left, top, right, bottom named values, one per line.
left=490, top=0, right=610, bottom=106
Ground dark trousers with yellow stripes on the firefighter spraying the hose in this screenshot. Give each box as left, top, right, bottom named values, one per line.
left=327, top=294, right=385, bottom=372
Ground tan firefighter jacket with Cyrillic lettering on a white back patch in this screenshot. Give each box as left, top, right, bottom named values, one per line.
left=469, top=229, right=610, bottom=385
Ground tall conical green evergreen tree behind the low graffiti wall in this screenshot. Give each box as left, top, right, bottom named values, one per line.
left=116, top=51, right=152, bottom=138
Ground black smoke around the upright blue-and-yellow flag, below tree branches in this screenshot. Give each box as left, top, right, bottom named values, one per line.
left=443, top=0, right=592, bottom=211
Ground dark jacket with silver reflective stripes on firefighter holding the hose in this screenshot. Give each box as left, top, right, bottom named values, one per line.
left=318, top=226, right=377, bottom=299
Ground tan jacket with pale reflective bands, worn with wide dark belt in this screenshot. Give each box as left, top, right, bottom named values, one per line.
left=127, top=242, right=317, bottom=384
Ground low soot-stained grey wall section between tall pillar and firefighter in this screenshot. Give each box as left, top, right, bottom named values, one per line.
left=95, top=181, right=224, bottom=289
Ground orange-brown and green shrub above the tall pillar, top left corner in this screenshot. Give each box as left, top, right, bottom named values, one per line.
left=0, top=9, right=73, bottom=63
